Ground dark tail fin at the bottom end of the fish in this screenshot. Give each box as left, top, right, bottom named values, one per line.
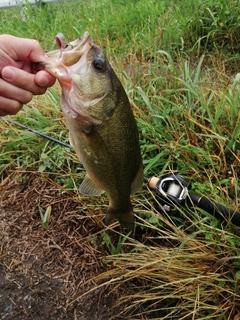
left=104, top=207, right=135, bottom=231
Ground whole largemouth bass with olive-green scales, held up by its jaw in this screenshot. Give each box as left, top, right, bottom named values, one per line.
left=45, top=32, right=143, bottom=230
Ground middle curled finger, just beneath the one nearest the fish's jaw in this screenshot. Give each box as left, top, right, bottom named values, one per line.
left=0, top=79, right=33, bottom=104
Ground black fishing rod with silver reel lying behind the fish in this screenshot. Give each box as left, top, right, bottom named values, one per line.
left=4, top=119, right=240, bottom=227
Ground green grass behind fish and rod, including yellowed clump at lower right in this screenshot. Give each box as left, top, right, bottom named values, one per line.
left=0, top=0, right=240, bottom=320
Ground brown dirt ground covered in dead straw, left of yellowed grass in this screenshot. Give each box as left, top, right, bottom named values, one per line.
left=0, top=172, right=128, bottom=320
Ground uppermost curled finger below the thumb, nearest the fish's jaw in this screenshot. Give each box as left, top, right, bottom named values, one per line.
left=2, top=67, right=46, bottom=95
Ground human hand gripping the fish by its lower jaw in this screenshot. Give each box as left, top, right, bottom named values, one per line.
left=0, top=35, right=55, bottom=116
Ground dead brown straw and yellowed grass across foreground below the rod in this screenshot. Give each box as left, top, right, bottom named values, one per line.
left=0, top=171, right=240, bottom=320
